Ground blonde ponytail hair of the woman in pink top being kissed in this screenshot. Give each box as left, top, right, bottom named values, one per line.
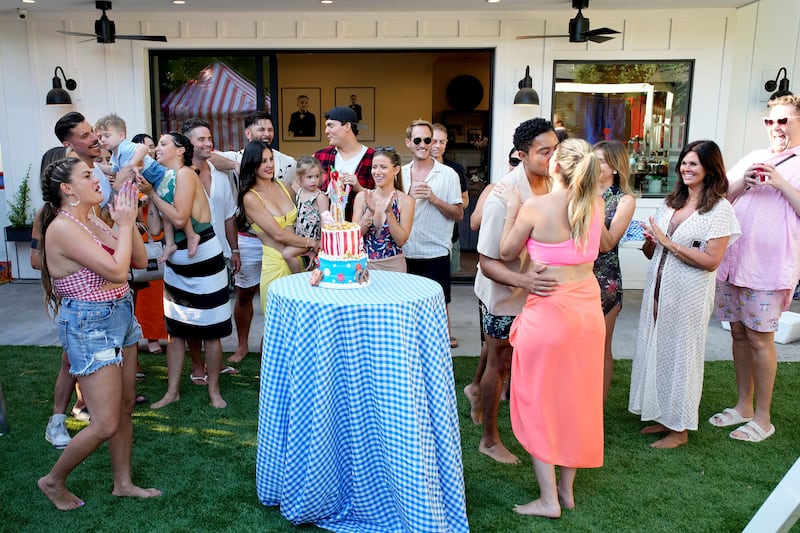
left=553, top=139, right=600, bottom=248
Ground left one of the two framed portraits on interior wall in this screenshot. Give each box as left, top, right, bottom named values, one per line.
left=281, top=87, right=325, bottom=141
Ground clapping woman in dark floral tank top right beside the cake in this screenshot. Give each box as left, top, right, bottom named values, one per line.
left=353, top=148, right=414, bottom=272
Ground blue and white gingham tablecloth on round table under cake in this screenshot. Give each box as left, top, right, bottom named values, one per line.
left=256, top=271, right=469, bottom=533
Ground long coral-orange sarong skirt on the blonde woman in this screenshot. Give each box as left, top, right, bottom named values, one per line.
left=509, top=278, right=606, bottom=468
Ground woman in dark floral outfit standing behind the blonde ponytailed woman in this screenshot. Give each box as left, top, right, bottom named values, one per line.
left=594, top=141, right=636, bottom=401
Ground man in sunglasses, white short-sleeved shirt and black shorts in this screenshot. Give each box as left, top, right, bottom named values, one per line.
left=402, top=120, right=464, bottom=340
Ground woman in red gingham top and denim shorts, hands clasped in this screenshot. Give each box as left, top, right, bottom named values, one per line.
left=38, top=158, right=161, bottom=510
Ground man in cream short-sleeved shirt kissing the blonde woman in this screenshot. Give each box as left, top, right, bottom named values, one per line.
left=472, top=118, right=558, bottom=464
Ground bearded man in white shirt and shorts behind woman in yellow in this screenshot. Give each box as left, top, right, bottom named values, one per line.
left=211, top=111, right=297, bottom=363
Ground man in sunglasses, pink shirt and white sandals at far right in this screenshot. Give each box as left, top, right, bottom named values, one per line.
left=709, top=96, right=800, bottom=442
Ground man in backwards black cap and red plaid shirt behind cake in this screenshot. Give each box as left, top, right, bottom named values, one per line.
left=314, top=106, right=375, bottom=220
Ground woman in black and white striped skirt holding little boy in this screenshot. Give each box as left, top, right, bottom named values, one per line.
left=138, top=132, right=232, bottom=409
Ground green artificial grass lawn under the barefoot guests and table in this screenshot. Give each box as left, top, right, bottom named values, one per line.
left=0, top=346, right=800, bottom=533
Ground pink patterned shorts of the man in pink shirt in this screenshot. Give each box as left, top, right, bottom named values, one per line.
left=714, top=280, right=792, bottom=332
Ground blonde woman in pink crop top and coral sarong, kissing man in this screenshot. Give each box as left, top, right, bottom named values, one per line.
left=493, top=139, right=605, bottom=518
